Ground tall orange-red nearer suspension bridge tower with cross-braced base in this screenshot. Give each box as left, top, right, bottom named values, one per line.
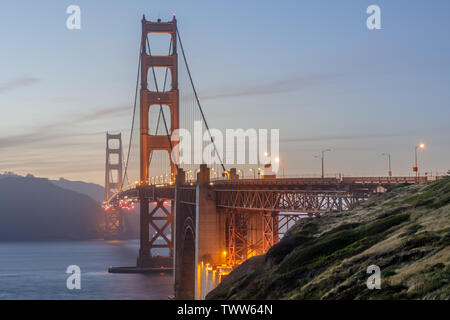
left=137, top=16, right=179, bottom=267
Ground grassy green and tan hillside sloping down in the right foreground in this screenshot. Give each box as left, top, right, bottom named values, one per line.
left=207, top=178, right=450, bottom=299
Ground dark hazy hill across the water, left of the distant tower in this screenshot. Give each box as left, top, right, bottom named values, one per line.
left=0, top=174, right=104, bottom=240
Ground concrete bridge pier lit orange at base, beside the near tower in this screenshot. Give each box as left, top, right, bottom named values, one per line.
left=174, top=165, right=227, bottom=300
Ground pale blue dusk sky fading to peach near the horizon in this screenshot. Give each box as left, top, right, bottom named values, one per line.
left=0, top=0, right=450, bottom=185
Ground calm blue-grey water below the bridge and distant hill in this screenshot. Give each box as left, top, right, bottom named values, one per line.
left=0, top=240, right=173, bottom=299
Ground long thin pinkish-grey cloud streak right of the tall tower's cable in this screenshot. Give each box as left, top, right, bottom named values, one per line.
left=201, top=72, right=352, bottom=100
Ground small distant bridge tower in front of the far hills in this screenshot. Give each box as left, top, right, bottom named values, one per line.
left=104, top=132, right=125, bottom=239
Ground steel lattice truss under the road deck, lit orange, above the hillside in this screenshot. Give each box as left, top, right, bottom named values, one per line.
left=216, top=189, right=368, bottom=266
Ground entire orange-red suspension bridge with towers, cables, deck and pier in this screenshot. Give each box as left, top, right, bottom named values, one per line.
left=100, top=16, right=426, bottom=299
